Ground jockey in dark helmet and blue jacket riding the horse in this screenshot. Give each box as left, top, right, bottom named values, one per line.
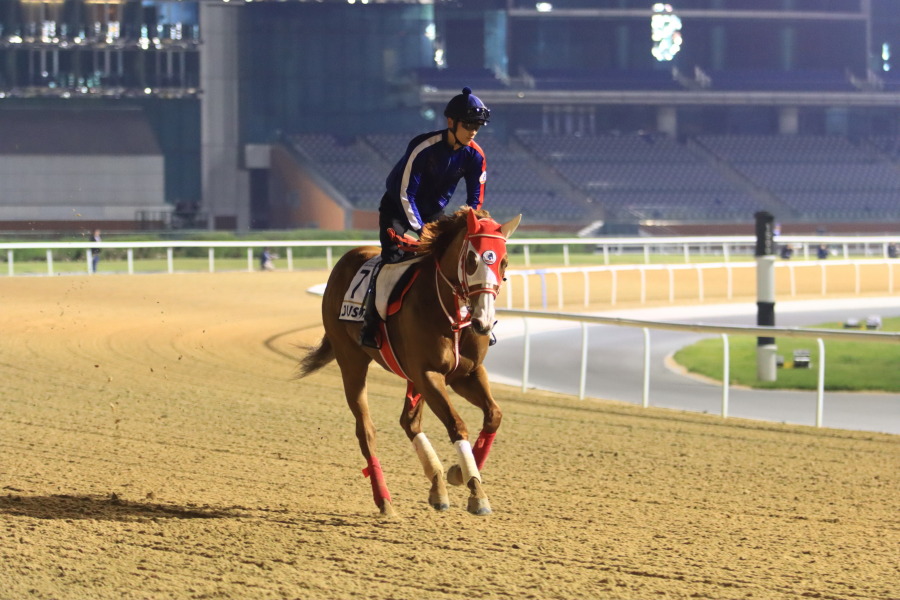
left=359, top=87, right=491, bottom=348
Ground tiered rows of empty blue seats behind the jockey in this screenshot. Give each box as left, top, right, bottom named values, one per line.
left=280, top=133, right=900, bottom=230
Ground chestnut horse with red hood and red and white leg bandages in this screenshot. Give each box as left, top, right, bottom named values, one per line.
left=298, top=207, right=522, bottom=516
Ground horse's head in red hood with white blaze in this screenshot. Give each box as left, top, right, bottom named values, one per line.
left=458, top=211, right=522, bottom=335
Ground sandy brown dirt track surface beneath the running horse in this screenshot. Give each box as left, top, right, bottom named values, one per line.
left=0, top=272, right=900, bottom=600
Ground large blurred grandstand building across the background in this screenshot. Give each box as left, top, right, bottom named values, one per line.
left=0, top=0, right=900, bottom=233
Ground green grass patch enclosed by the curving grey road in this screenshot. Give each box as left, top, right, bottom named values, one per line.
left=675, top=317, right=900, bottom=392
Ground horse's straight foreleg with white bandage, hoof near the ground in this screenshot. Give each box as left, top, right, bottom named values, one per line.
left=421, top=373, right=491, bottom=515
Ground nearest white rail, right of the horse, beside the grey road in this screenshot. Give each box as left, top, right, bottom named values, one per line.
left=497, top=309, right=900, bottom=427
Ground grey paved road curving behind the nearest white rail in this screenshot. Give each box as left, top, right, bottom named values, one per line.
left=486, top=298, right=900, bottom=434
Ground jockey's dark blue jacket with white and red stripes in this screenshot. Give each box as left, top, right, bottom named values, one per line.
left=385, top=129, right=487, bottom=231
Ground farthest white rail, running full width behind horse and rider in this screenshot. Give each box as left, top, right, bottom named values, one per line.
left=0, top=236, right=895, bottom=275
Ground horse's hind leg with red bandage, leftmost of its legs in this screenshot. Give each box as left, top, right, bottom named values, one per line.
left=341, top=364, right=396, bottom=516
